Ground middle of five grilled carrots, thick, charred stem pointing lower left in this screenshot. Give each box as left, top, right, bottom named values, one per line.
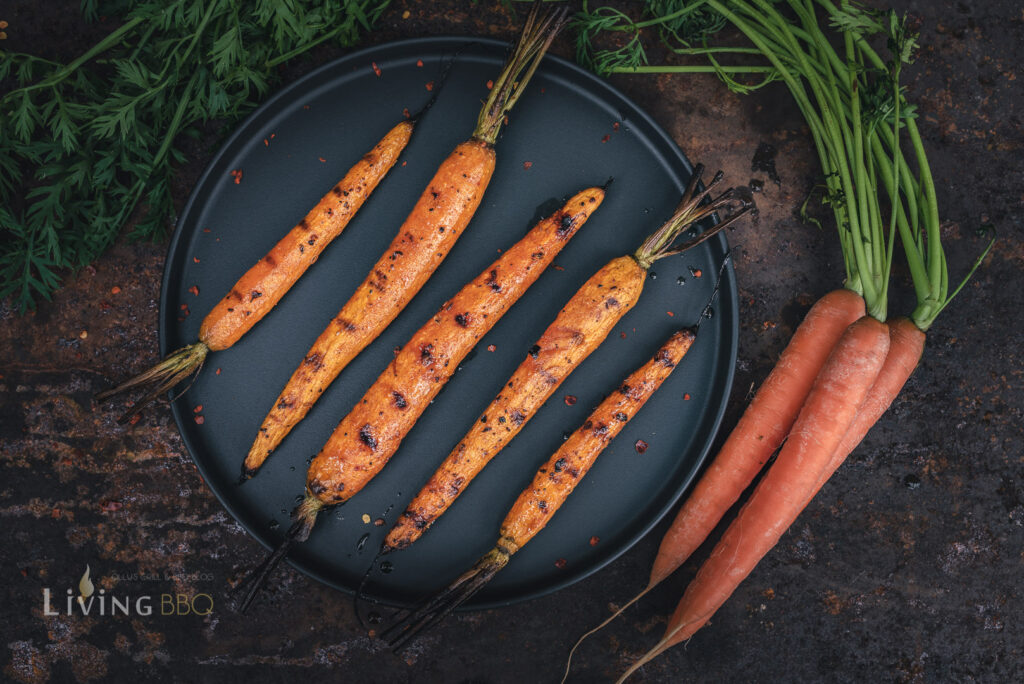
left=235, top=180, right=604, bottom=610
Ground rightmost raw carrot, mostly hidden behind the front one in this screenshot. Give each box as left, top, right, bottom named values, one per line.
left=808, top=316, right=925, bottom=503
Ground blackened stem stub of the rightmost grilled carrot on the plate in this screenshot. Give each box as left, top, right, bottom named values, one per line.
left=381, top=546, right=512, bottom=651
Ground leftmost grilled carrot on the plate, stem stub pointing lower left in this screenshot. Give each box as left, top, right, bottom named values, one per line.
left=96, top=116, right=415, bottom=420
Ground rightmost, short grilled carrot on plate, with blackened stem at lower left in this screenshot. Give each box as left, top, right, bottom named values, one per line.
left=382, top=330, right=695, bottom=648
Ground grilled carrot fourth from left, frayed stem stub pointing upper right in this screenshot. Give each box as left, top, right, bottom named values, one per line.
left=381, top=166, right=753, bottom=553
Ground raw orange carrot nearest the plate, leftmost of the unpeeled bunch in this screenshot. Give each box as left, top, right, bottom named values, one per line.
left=647, top=290, right=864, bottom=589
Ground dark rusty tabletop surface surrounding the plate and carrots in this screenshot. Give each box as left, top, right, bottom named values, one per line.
left=0, top=0, right=1024, bottom=683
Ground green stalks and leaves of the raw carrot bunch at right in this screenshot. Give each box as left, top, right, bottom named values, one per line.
left=575, top=0, right=991, bottom=331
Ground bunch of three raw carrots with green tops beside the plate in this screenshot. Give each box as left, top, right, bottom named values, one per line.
left=566, top=0, right=991, bottom=681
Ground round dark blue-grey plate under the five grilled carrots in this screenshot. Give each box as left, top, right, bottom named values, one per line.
left=160, top=38, right=737, bottom=607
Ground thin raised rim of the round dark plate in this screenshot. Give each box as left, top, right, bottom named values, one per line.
left=158, top=36, right=739, bottom=610
